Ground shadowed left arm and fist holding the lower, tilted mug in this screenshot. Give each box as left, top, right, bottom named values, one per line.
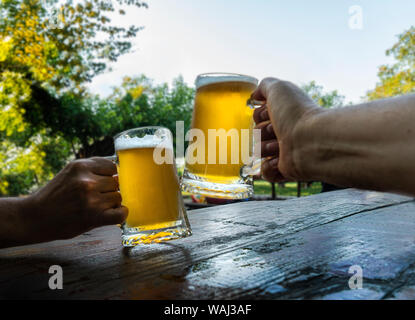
left=0, top=158, right=128, bottom=248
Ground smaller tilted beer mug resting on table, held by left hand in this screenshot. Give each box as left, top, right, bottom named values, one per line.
left=107, top=127, right=191, bottom=247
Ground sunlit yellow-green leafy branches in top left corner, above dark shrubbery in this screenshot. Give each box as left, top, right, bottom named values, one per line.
left=0, top=0, right=146, bottom=91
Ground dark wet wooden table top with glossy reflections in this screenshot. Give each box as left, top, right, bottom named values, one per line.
left=0, top=189, right=415, bottom=299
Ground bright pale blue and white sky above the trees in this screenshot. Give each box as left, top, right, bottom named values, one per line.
left=91, top=0, right=415, bottom=102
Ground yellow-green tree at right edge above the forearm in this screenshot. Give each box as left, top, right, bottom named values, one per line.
left=367, top=26, right=415, bottom=100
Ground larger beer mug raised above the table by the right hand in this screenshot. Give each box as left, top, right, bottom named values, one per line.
left=182, top=73, right=260, bottom=199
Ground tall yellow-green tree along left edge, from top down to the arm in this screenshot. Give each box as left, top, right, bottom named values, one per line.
left=0, top=0, right=146, bottom=195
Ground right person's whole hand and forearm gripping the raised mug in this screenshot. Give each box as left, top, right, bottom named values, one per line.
left=253, top=78, right=415, bottom=196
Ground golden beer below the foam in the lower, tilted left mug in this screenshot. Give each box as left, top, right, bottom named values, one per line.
left=117, top=148, right=180, bottom=230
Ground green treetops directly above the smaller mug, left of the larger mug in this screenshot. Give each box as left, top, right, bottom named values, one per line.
left=96, top=75, right=194, bottom=149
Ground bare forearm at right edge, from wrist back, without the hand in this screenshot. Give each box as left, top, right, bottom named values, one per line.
left=295, top=95, right=415, bottom=195
